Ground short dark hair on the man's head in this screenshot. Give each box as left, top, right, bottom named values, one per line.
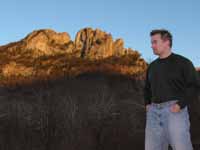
left=150, top=29, right=172, bottom=47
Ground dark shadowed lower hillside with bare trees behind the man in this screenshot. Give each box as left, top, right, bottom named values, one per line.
left=0, top=73, right=200, bottom=150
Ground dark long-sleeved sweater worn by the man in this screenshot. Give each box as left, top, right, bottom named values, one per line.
left=144, top=53, right=200, bottom=108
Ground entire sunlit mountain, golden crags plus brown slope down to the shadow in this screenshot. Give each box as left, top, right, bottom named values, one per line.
left=0, top=28, right=147, bottom=84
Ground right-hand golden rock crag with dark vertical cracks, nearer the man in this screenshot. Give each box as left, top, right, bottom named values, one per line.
left=75, top=28, right=134, bottom=59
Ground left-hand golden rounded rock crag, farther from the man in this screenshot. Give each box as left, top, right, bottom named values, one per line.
left=3, top=29, right=71, bottom=57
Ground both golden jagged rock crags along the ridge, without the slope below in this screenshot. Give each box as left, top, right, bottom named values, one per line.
left=0, top=28, right=139, bottom=59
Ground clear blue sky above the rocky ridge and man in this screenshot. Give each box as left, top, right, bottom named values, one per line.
left=0, top=0, right=200, bottom=66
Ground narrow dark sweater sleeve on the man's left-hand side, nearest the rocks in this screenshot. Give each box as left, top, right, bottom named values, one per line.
left=144, top=67, right=152, bottom=106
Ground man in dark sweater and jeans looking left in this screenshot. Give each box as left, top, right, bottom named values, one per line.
left=144, top=29, right=199, bottom=150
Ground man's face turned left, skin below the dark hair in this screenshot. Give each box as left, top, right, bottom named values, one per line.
left=151, top=34, right=169, bottom=55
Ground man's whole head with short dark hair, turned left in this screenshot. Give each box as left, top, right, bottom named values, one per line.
left=150, top=29, right=172, bottom=55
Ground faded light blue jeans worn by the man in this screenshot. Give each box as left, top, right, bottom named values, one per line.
left=145, top=100, right=193, bottom=150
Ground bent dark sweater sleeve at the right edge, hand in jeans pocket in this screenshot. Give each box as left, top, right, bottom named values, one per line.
left=177, top=61, right=200, bottom=109
